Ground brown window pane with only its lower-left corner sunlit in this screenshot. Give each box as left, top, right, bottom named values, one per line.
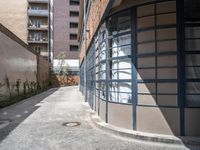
left=137, top=69, right=156, bottom=80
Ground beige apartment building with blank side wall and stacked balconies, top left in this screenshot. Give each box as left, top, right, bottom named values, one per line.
left=0, top=0, right=52, bottom=60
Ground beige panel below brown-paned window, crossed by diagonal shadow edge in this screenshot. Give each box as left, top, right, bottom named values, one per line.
left=136, top=106, right=180, bottom=135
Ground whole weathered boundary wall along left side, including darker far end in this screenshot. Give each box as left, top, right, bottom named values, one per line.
left=0, top=24, right=50, bottom=100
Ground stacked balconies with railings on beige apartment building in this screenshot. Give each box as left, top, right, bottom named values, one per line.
left=27, top=0, right=50, bottom=57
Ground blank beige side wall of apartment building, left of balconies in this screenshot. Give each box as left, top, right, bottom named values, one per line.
left=0, top=0, right=27, bottom=43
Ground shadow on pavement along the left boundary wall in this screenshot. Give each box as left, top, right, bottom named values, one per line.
left=0, top=88, right=59, bottom=142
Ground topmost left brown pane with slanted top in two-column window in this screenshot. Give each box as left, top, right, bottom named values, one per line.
left=137, top=4, right=155, bottom=17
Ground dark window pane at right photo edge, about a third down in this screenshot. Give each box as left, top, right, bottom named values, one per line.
left=185, top=39, right=200, bottom=51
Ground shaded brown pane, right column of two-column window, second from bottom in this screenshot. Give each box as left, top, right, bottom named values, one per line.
left=157, top=83, right=177, bottom=94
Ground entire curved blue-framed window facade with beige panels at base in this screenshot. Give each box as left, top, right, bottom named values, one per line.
left=80, top=0, right=200, bottom=135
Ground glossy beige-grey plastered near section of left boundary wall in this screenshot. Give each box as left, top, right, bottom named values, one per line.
left=0, top=32, right=37, bottom=100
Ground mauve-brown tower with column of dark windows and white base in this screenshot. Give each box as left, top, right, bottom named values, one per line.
left=53, top=0, right=79, bottom=75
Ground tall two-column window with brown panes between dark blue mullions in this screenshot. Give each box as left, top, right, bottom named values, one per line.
left=137, top=1, right=178, bottom=106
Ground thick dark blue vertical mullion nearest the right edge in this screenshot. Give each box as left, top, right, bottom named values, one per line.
left=176, top=0, right=185, bottom=136
